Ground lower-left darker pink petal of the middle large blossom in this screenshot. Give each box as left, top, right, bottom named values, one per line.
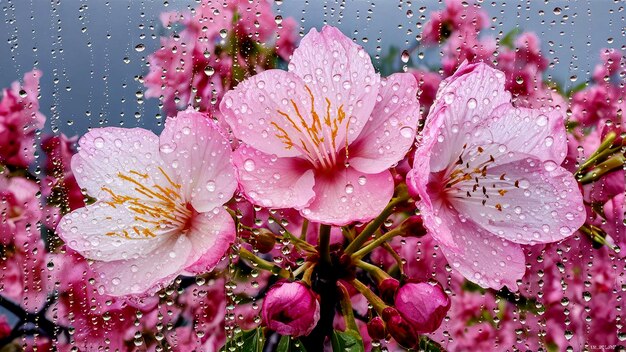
left=233, top=145, right=315, bottom=209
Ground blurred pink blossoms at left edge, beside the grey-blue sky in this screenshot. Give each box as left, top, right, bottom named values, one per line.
left=0, top=70, right=46, bottom=167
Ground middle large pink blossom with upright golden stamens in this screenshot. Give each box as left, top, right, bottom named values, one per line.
left=220, top=26, right=419, bottom=225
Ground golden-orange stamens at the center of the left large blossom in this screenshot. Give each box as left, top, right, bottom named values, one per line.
left=102, top=167, right=193, bottom=239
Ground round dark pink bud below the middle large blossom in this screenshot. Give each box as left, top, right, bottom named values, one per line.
left=261, top=281, right=320, bottom=337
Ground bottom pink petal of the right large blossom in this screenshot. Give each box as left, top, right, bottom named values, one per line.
left=441, top=220, right=526, bottom=291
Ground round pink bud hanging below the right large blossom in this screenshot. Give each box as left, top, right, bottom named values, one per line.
left=395, top=282, right=450, bottom=333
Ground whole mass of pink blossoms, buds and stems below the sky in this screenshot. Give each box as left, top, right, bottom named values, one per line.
left=0, top=0, right=626, bottom=351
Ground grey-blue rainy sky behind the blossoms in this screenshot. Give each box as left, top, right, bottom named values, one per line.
left=0, top=0, right=626, bottom=136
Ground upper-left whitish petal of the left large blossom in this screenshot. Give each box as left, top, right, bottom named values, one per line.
left=71, top=127, right=164, bottom=199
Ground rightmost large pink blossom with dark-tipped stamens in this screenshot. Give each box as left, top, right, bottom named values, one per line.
left=408, top=63, right=585, bottom=289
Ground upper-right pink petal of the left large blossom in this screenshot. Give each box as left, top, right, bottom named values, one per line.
left=159, top=110, right=237, bottom=212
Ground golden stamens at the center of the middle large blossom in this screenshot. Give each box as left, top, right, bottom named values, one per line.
left=271, top=85, right=350, bottom=169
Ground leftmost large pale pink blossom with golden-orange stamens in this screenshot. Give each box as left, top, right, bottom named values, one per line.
left=57, top=110, right=236, bottom=296
